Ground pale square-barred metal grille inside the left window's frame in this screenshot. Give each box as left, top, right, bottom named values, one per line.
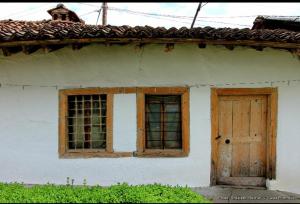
left=67, top=94, right=107, bottom=150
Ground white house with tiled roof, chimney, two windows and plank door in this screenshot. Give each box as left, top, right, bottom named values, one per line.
left=0, top=5, right=300, bottom=193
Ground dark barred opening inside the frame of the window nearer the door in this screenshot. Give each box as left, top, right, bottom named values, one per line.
left=145, top=95, right=182, bottom=149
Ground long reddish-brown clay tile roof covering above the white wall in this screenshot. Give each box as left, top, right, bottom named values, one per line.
left=0, top=20, right=300, bottom=43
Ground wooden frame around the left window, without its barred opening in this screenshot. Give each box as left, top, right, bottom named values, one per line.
left=58, top=87, right=136, bottom=158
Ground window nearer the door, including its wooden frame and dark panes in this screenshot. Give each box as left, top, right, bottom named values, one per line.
left=136, top=87, right=189, bottom=156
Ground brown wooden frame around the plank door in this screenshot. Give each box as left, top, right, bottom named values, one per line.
left=210, top=87, right=278, bottom=186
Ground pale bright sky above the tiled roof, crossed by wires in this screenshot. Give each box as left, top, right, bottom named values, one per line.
left=0, top=2, right=300, bottom=28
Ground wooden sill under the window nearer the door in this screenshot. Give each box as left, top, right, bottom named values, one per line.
left=133, top=150, right=188, bottom=157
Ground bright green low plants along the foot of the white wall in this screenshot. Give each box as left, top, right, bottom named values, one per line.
left=0, top=183, right=211, bottom=203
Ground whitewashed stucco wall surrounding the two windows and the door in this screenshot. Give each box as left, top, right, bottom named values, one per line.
left=0, top=44, right=300, bottom=193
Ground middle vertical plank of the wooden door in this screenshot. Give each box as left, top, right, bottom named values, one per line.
left=232, top=99, right=251, bottom=177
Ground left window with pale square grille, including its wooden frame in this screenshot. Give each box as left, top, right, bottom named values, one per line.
left=59, top=88, right=132, bottom=158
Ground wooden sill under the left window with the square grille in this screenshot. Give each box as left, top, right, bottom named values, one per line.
left=59, top=151, right=133, bottom=159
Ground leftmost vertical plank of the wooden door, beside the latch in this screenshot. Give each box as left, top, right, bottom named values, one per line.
left=216, top=98, right=232, bottom=178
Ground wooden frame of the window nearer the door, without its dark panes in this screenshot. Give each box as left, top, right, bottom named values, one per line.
left=134, top=87, right=190, bottom=157
